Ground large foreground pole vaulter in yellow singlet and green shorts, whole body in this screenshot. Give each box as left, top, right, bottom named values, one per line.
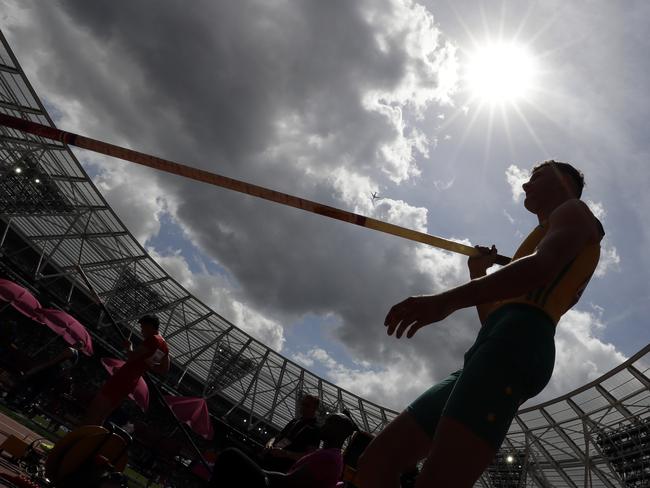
left=358, top=160, right=604, bottom=488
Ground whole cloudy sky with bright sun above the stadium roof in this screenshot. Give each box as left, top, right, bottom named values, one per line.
left=0, top=0, right=650, bottom=408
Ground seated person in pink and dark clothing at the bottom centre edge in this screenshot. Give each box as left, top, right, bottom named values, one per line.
left=210, top=414, right=357, bottom=488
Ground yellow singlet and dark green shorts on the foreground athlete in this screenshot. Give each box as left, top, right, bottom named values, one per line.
left=407, top=212, right=604, bottom=449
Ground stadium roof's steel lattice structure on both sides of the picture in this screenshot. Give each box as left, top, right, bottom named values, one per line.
left=0, top=28, right=650, bottom=488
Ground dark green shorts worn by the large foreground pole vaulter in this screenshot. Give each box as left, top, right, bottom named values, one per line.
left=407, top=303, right=555, bottom=449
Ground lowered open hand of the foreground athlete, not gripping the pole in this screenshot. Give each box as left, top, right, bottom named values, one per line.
left=384, top=295, right=455, bottom=339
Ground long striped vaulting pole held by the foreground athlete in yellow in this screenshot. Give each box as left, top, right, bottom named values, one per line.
left=0, top=113, right=510, bottom=265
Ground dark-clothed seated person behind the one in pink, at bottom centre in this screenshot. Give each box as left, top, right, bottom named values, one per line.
left=262, top=395, right=320, bottom=473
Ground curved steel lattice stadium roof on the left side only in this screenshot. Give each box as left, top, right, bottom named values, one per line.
left=0, top=28, right=395, bottom=432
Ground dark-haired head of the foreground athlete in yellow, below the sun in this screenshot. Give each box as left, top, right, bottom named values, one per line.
left=523, top=159, right=585, bottom=213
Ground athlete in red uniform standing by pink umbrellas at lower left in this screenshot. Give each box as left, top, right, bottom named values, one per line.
left=83, top=315, right=170, bottom=425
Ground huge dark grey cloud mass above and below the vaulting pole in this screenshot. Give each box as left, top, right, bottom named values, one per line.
left=3, top=0, right=486, bottom=404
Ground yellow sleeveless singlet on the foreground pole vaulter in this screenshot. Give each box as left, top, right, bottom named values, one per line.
left=492, top=213, right=605, bottom=324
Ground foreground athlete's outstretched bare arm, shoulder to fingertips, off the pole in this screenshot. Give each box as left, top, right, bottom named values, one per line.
left=385, top=200, right=600, bottom=338
